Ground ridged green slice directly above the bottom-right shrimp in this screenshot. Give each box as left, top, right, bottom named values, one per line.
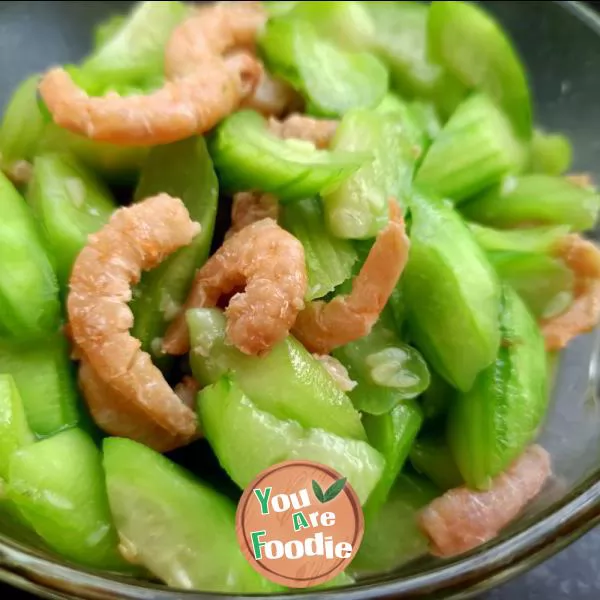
left=448, top=286, right=548, bottom=489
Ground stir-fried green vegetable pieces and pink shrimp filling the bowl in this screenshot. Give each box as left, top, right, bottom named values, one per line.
left=0, top=1, right=600, bottom=593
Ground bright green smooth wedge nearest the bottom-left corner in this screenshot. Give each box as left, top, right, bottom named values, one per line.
left=8, top=429, right=131, bottom=571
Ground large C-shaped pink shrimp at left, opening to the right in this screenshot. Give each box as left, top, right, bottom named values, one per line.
left=67, top=194, right=200, bottom=449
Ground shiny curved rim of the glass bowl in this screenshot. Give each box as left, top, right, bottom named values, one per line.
left=0, top=0, right=600, bottom=600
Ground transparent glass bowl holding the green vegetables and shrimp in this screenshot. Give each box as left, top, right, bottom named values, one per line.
left=0, top=1, right=600, bottom=600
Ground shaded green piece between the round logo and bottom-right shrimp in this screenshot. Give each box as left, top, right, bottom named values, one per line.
left=351, top=473, right=440, bottom=575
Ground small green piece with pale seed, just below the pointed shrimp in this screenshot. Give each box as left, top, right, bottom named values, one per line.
left=333, top=318, right=429, bottom=415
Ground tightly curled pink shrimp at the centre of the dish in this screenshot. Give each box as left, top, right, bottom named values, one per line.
left=163, top=219, right=308, bottom=355
